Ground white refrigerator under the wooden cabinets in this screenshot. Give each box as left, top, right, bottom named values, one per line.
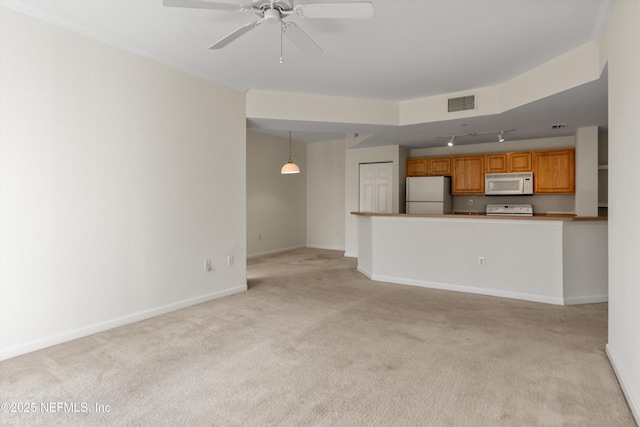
left=406, top=176, right=453, bottom=214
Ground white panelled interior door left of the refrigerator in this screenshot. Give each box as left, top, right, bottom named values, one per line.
left=359, top=162, right=393, bottom=213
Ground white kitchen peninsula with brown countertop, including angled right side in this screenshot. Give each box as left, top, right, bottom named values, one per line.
left=352, top=212, right=608, bottom=305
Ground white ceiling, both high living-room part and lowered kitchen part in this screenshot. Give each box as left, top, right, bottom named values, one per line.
left=0, top=0, right=611, bottom=148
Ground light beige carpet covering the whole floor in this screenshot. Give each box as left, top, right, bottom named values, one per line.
left=0, top=249, right=635, bottom=426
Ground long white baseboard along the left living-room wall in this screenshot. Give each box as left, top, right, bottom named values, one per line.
left=0, top=284, right=247, bottom=360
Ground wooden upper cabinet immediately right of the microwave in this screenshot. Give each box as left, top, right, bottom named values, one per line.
left=533, top=149, right=576, bottom=194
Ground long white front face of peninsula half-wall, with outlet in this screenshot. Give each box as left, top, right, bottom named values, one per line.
left=372, top=217, right=562, bottom=304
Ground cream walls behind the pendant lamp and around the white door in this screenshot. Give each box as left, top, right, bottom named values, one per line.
left=247, top=132, right=406, bottom=257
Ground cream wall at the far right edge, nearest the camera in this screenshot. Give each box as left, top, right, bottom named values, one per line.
left=601, top=0, right=640, bottom=423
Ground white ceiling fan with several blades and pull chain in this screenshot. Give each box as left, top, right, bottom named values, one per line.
left=162, top=0, right=373, bottom=58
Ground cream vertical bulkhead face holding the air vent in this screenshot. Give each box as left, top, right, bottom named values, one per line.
left=247, top=42, right=601, bottom=132
